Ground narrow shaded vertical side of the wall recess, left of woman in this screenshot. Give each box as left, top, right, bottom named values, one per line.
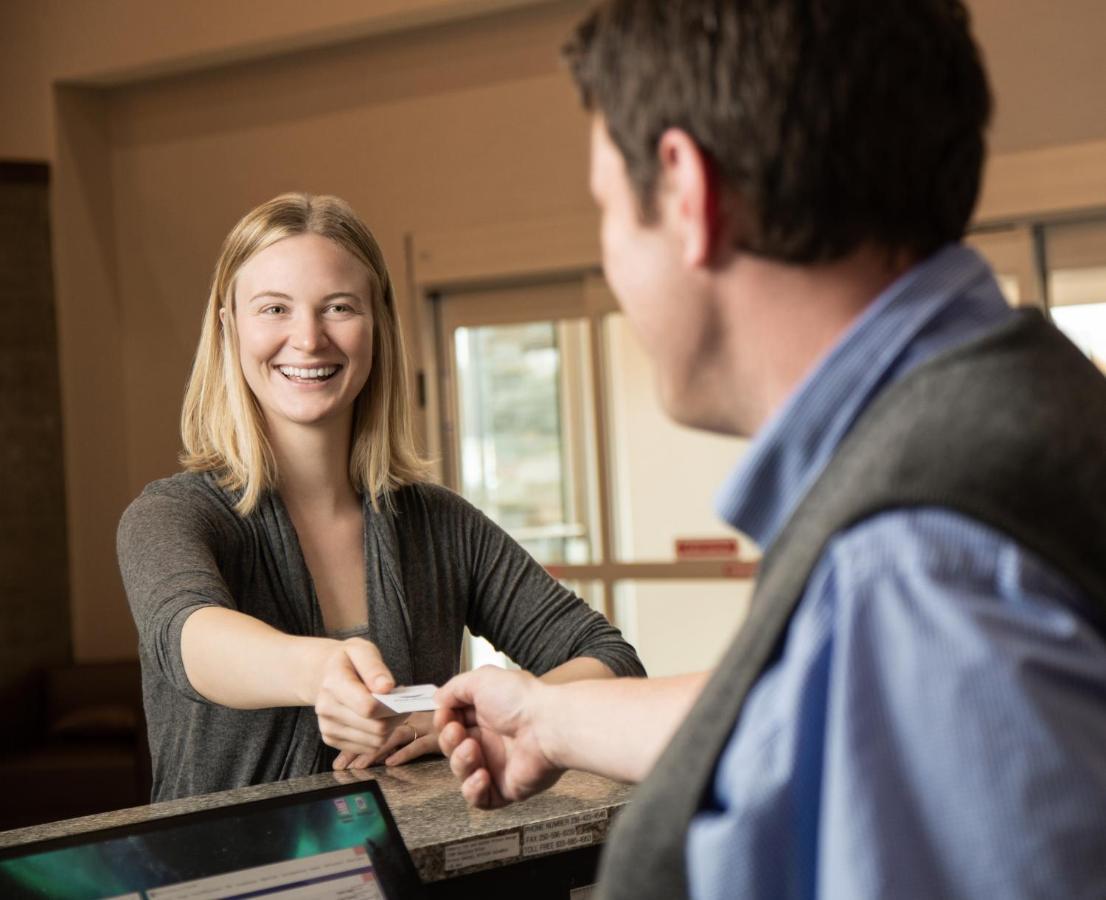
left=52, top=87, right=133, bottom=660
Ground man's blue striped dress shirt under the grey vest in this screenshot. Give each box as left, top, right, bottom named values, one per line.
left=687, top=245, right=1106, bottom=900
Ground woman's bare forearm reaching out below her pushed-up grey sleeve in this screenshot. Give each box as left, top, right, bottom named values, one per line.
left=180, top=606, right=336, bottom=710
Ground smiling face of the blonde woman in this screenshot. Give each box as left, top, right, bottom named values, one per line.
left=227, top=234, right=375, bottom=432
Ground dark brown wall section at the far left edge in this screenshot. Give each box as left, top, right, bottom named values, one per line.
left=0, top=163, right=70, bottom=750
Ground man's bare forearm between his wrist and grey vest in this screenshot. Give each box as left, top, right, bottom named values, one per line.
left=534, top=672, right=710, bottom=782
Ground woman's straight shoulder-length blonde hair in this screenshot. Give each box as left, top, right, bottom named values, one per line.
left=180, top=193, right=426, bottom=515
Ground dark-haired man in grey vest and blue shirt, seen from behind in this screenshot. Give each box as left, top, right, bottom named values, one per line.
left=429, top=0, right=1106, bottom=900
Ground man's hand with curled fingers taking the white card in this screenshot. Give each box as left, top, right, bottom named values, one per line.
left=434, top=666, right=564, bottom=809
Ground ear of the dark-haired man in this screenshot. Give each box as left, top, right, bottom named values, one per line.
left=657, top=128, right=727, bottom=266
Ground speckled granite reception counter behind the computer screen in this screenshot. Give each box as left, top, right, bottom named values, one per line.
left=0, top=760, right=630, bottom=900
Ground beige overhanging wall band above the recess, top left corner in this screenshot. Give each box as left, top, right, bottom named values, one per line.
left=0, top=0, right=557, bottom=159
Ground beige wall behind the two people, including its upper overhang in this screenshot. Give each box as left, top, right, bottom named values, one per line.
left=0, top=0, right=1106, bottom=659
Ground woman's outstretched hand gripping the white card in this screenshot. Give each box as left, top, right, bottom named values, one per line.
left=314, top=638, right=413, bottom=768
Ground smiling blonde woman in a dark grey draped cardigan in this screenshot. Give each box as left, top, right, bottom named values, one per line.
left=118, top=193, right=643, bottom=800
